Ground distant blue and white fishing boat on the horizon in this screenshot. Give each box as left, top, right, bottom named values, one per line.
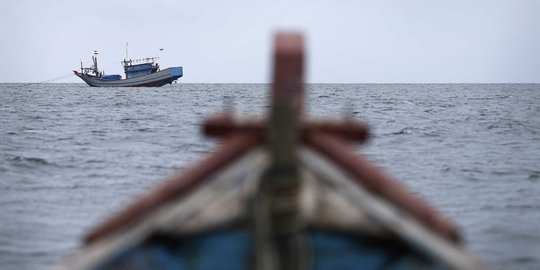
left=73, top=46, right=183, bottom=87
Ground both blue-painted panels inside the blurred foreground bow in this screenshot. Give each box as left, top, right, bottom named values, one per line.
left=95, top=229, right=447, bottom=270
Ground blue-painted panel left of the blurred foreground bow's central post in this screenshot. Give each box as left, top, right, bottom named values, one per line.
left=95, top=230, right=251, bottom=270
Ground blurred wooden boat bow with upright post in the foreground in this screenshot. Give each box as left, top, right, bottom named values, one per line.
left=55, top=33, right=481, bottom=270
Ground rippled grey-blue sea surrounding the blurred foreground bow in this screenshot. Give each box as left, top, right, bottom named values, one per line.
left=0, top=83, right=540, bottom=270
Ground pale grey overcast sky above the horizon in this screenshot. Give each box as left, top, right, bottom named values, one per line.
left=0, top=0, right=540, bottom=83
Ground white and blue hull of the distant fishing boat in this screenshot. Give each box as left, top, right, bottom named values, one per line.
left=73, top=67, right=183, bottom=87
